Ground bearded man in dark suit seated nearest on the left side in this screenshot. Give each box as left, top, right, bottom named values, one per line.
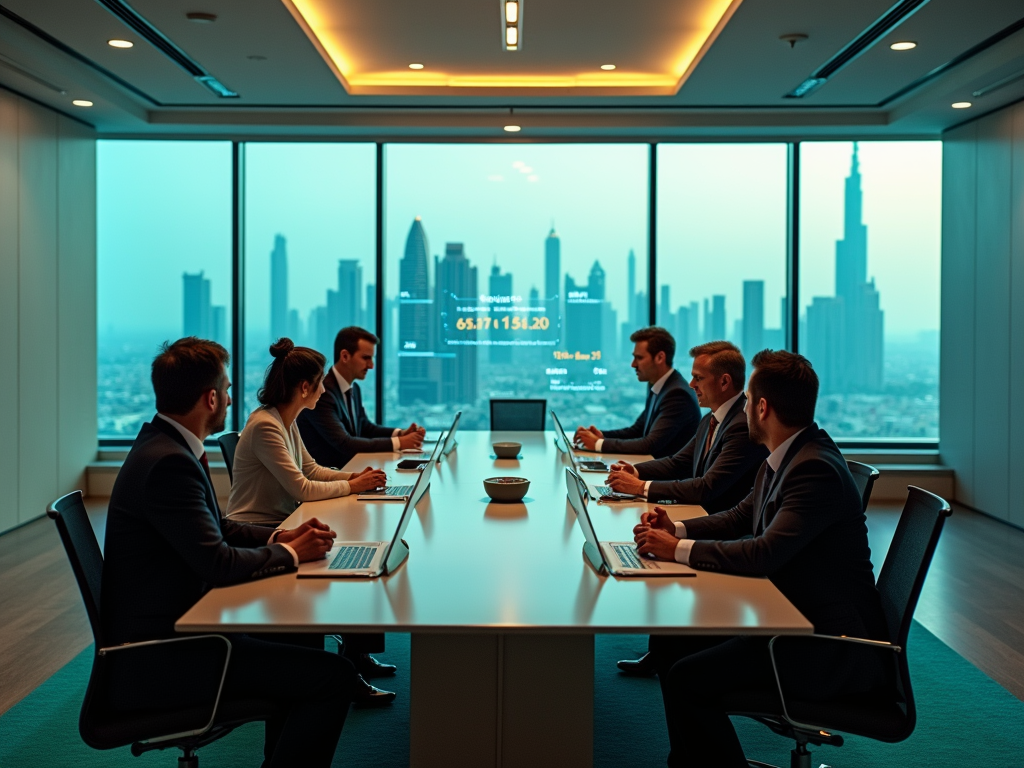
left=101, top=337, right=372, bottom=766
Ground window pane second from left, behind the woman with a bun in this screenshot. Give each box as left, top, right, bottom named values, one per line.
left=245, top=143, right=377, bottom=418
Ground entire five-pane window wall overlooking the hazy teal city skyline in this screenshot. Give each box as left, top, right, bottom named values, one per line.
left=97, top=140, right=941, bottom=443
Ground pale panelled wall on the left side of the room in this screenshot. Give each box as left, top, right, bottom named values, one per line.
left=0, top=90, right=96, bottom=531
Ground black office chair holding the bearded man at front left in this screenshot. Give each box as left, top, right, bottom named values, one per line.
left=46, top=490, right=276, bottom=768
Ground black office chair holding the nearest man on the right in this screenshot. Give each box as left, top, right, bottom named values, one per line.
left=729, top=485, right=952, bottom=768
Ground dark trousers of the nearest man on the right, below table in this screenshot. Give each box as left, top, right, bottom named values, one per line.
left=650, top=635, right=780, bottom=768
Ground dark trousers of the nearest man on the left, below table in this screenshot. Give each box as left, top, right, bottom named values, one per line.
left=223, top=635, right=356, bottom=768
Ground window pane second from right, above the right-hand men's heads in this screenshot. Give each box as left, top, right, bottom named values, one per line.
left=655, top=144, right=788, bottom=375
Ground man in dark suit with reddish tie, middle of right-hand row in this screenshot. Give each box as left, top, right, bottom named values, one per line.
left=607, top=341, right=768, bottom=675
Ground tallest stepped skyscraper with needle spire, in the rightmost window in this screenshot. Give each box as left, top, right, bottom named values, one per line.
left=807, top=142, right=885, bottom=393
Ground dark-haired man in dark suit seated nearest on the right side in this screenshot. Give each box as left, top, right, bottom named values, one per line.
left=635, top=350, right=886, bottom=768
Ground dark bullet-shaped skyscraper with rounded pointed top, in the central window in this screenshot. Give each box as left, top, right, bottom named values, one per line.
left=397, top=216, right=438, bottom=406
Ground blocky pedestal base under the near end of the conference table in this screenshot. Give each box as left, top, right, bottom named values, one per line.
left=410, top=633, right=594, bottom=768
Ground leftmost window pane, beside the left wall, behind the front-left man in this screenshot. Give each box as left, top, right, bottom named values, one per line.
left=96, top=140, right=232, bottom=438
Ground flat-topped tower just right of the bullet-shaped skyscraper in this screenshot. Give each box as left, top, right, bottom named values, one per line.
left=434, top=243, right=477, bottom=403
